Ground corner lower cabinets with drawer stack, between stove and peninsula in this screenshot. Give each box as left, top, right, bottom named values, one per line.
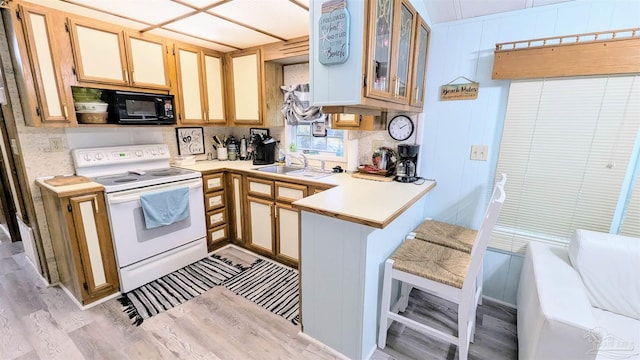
left=196, top=171, right=324, bottom=267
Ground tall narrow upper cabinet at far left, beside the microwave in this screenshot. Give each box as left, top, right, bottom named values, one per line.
left=12, top=5, right=75, bottom=126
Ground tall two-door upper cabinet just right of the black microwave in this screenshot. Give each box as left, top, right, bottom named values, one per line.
left=174, top=44, right=226, bottom=125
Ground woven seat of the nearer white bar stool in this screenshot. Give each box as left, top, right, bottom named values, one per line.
left=391, top=239, right=471, bottom=289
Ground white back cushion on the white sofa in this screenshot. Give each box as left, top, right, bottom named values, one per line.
left=569, top=230, right=640, bottom=320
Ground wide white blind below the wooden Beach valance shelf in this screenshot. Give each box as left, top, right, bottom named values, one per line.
left=490, top=76, right=640, bottom=253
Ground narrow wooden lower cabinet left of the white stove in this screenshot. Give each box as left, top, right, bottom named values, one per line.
left=42, top=187, right=119, bottom=305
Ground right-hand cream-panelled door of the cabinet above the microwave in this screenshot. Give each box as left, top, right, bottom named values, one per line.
left=127, top=35, right=169, bottom=89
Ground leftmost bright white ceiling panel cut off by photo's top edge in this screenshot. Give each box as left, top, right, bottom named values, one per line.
left=64, top=0, right=194, bottom=24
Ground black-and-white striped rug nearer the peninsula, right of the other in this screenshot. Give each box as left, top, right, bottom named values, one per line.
left=223, top=259, right=300, bottom=325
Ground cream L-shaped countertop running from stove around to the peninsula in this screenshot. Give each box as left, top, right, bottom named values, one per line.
left=179, top=160, right=436, bottom=229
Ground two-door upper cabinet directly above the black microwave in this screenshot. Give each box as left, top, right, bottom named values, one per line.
left=68, top=18, right=170, bottom=90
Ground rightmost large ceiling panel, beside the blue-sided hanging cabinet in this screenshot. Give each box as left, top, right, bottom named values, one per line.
left=208, top=0, right=309, bottom=40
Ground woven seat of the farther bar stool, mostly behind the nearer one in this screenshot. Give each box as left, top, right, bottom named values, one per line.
left=413, top=220, right=478, bottom=254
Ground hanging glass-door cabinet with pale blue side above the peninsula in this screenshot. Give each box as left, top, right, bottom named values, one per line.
left=309, top=0, right=429, bottom=112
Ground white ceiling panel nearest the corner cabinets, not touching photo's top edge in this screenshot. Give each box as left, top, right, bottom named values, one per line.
left=164, top=13, right=278, bottom=49
